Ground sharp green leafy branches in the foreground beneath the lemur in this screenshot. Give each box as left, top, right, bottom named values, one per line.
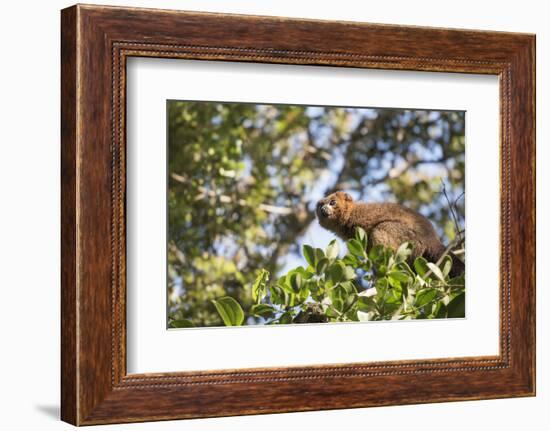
left=172, top=229, right=465, bottom=326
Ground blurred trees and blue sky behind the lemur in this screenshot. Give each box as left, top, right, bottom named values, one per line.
left=167, top=101, right=465, bottom=326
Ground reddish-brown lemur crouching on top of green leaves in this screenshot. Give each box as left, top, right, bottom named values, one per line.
left=317, top=192, right=464, bottom=277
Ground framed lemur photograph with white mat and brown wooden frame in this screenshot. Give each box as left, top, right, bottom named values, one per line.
left=61, top=5, right=535, bottom=425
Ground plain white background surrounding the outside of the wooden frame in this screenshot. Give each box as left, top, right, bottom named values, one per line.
left=0, top=0, right=550, bottom=431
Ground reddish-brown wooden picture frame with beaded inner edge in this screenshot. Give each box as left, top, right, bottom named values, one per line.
left=61, top=5, right=535, bottom=425
